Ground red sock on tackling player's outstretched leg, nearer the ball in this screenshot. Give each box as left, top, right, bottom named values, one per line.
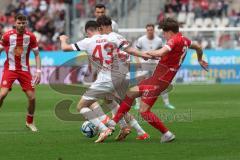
left=113, top=96, right=134, bottom=123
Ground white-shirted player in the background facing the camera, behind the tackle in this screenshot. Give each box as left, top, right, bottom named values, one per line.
left=134, top=24, right=175, bottom=109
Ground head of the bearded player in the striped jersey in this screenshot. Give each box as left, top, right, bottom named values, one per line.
left=15, top=13, right=27, bottom=34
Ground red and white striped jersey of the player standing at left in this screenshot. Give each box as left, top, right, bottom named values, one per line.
left=0, top=29, right=38, bottom=71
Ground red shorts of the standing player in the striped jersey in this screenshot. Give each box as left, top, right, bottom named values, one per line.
left=1, top=70, right=34, bottom=91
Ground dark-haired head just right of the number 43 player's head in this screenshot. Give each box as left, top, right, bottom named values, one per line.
left=97, top=15, right=112, bottom=34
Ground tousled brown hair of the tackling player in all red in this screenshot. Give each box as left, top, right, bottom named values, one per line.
left=158, top=18, right=179, bottom=33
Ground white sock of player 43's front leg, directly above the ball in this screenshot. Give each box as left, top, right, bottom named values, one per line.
left=80, top=107, right=108, bottom=132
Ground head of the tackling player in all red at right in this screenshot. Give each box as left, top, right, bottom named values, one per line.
left=159, top=18, right=179, bottom=40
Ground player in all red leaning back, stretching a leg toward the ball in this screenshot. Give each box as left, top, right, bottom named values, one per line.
left=97, top=18, right=208, bottom=143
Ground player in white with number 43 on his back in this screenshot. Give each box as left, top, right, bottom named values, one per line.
left=60, top=21, right=151, bottom=143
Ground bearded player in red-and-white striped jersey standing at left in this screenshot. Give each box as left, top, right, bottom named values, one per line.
left=0, top=14, right=41, bottom=132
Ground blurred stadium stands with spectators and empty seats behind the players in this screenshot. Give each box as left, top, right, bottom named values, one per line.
left=0, top=0, right=240, bottom=51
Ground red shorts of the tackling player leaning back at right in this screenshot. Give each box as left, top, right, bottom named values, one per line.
left=138, top=64, right=177, bottom=106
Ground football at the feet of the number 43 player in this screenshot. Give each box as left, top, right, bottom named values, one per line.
left=81, top=121, right=97, bottom=138
